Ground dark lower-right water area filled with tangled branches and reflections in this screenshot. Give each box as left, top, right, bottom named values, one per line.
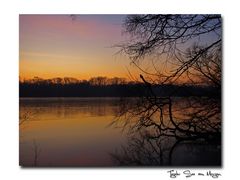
left=111, top=97, right=221, bottom=166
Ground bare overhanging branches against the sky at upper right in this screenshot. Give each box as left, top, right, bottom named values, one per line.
left=120, top=15, right=221, bottom=86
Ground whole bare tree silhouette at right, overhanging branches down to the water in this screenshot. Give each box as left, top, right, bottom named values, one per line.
left=112, top=15, right=221, bottom=165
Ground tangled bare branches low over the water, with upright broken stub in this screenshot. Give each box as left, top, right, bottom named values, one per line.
left=112, top=75, right=221, bottom=165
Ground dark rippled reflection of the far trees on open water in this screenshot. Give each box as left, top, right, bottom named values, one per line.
left=20, top=98, right=122, bottom=120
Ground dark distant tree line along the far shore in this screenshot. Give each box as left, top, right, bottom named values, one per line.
left=19, top=76, right=218, bottom=97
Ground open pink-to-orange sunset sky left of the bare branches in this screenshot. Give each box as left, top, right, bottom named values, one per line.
left=19, top=15, right=137, bottom=79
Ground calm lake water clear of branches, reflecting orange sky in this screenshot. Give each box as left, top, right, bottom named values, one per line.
left=19, top=98, right=221, bottom=166
